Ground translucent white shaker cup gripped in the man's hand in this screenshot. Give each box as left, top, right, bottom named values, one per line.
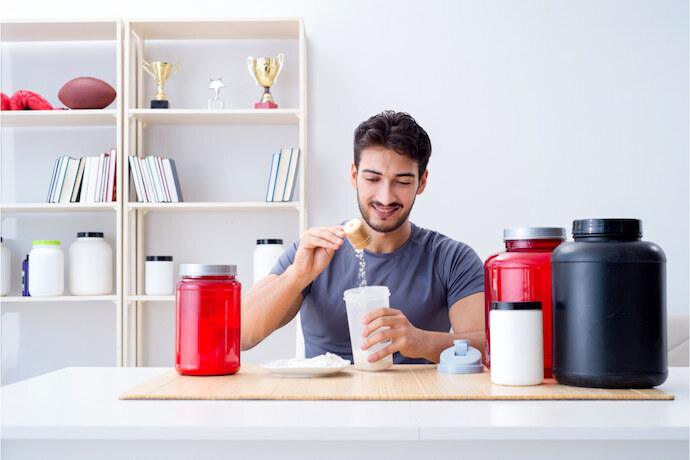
left=343, top=286, right=393, bottom=371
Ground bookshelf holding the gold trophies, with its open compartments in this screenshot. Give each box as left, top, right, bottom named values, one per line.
left=122, top=19, right=308, bottom=365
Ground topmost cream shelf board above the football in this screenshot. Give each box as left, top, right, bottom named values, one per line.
left=0, top=21, right=118, bottom=43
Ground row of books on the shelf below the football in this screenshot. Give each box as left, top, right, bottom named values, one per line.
left=46, top=149, right=117, bottom=203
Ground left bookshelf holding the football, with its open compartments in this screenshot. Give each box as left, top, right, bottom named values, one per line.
left=0, top=20, right=124, bottom=373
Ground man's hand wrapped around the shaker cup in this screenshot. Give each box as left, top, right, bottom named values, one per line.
left=362, top=308, right=425, bottom=363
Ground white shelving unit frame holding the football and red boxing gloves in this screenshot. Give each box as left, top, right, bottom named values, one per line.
left=0, top=20, right=124, bottom=365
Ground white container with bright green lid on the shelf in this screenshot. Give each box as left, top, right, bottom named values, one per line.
left=29, top=240, right=65, bottom=297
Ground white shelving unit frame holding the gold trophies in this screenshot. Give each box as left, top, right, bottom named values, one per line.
left=123, top=19, right=308, bottom=365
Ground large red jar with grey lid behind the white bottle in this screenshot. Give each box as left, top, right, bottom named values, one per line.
left=484, top=227, right=566, bottom=377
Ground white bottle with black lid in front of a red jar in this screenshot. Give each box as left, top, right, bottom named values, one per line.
left=489, top=302, right=544, bottom=386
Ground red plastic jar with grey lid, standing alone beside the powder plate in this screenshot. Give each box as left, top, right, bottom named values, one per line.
left=175, top=264, right=242, bottom=375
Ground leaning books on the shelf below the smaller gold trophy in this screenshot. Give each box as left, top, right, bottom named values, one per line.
left=129, top=155, right=184, bottom=203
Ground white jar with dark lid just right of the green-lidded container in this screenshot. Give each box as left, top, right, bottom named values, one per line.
left=68, top=232, right=113, bottom=295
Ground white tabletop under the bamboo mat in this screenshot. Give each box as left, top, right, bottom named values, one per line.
left=1, top=368, right=690, bottom=456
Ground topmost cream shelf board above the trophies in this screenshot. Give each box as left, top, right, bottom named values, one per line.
left=129, top=19, right=300, bottom=40
